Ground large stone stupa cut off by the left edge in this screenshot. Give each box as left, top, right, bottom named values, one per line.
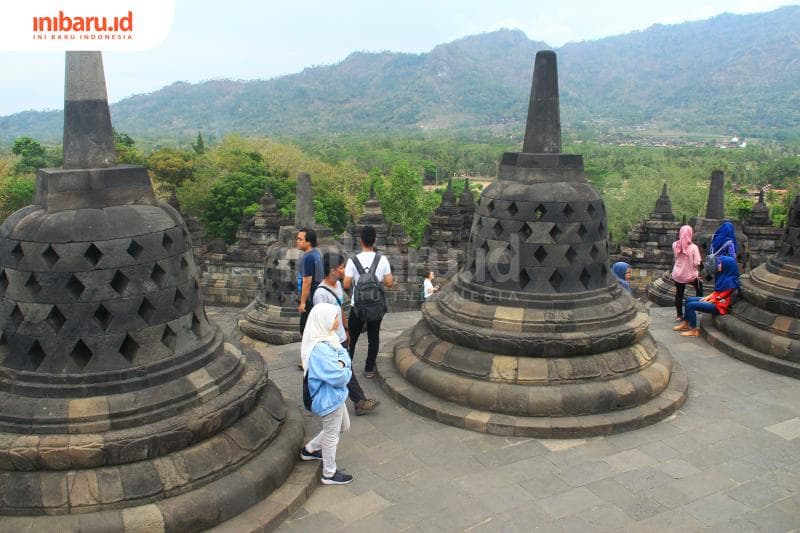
left=0, top=52, right=303, bottom=531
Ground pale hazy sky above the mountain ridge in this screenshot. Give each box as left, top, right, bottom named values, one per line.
left=0, top=0, right=800, bottom=116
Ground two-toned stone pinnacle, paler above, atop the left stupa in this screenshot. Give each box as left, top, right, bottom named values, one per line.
left=64, top=52, right=116, bottom=169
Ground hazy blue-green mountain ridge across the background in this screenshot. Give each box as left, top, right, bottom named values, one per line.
left=0, top=6, right=800, bottom=141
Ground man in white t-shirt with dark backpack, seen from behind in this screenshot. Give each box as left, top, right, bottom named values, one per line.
left=343, top=226, right=394, bottom=379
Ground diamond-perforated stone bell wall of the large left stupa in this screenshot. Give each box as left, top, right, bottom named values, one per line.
left=0, top=226, right=211, bottom=374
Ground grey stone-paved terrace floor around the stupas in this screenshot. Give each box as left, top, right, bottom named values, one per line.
left=209, top=308, right=800, bottom=533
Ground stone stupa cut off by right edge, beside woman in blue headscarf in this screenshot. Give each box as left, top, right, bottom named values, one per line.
left=700, top=195, right=800, bottom=378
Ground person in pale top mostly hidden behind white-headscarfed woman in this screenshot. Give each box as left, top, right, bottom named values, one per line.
left=313, top=252, right=380, bottom=416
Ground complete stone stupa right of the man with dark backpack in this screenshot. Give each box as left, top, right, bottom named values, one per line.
left=378, top=51, right=688, bottom=438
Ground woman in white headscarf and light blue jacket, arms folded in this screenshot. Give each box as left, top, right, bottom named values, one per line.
left=300, top=303, right=353, bottom=485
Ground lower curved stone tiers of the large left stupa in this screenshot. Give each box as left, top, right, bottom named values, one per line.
left=0, top=382, right=306, bottom=532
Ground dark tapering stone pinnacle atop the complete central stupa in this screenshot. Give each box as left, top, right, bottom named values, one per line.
left=522, top=50, right=561, bottom=154
